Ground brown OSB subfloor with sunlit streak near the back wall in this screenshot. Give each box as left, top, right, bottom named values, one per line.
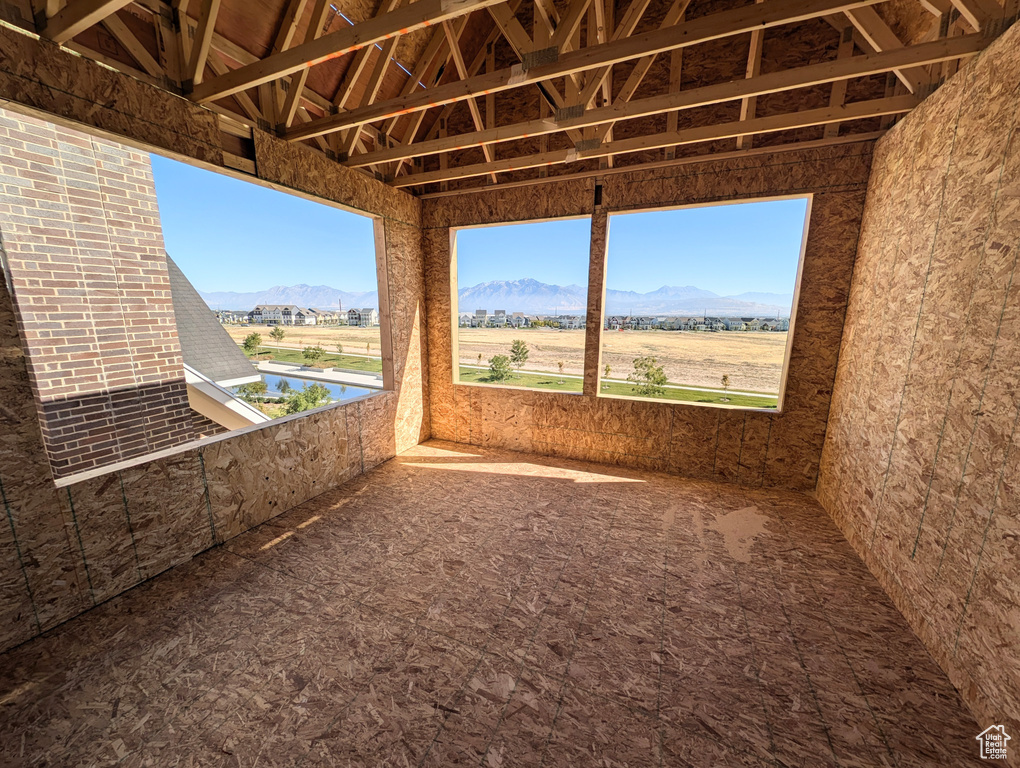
left=0, top=442, right=978, bottom=768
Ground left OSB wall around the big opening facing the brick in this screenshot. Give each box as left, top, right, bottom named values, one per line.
left=0, top=28, right=430, bottom=651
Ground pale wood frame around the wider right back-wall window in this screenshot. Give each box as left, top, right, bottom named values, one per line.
left=595, top=192, right=814, bottom=414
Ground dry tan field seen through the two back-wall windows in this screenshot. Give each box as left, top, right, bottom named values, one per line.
left=458, top=328, right=786, bottom=393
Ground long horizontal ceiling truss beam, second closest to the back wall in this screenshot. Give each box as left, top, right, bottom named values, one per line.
left=347, top=35, right=987, bottom=166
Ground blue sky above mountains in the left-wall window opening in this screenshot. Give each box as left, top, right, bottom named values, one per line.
left=151, top=155, right=375, bottom=292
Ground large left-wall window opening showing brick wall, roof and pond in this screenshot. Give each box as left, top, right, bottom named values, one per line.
left=0, top=109, right=385, bottom=482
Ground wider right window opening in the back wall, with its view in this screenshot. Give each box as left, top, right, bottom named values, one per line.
left=599, top=197, right=811, bottom=410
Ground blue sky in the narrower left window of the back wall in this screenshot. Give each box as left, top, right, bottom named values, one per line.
left=457, top=217, right=592, bottom=288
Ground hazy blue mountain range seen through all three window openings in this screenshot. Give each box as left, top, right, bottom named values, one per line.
left=199, top=277, right=794, bottom=317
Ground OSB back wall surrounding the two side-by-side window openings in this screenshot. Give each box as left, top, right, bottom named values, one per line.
left=422, top=144, right=871, bottom=489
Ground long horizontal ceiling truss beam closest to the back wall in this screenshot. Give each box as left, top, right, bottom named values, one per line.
left=391, top=95, right=920, bottom=187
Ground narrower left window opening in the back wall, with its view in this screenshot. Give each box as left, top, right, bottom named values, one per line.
left=452, top=217, right=591, bottom=393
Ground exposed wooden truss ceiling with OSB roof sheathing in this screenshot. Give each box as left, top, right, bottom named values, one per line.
left=20, top=0, right=1020, bottom=194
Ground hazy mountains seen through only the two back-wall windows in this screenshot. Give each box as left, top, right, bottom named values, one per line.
left=458, top=278, right=794, bottom=317
